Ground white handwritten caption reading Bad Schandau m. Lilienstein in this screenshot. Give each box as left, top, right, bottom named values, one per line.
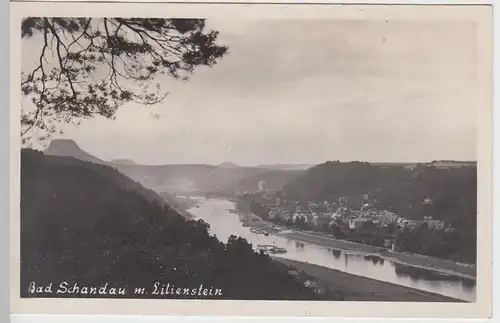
left=28, top=282, right=222, bottom=296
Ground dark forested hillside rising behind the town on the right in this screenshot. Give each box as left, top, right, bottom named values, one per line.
left=283, top=162, right=477, bottom=226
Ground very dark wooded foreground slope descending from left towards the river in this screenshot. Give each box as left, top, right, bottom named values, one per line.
left=21, top=150, right=318, bottom=300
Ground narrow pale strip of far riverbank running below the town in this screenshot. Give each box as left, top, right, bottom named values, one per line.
left=276, top=231, right=476, bottom=280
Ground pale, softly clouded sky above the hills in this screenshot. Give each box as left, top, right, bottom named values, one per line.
left=23, top=20, right=477, bottom=165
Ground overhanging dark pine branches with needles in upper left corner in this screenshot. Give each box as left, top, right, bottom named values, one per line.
left=21, top=17, right=227, bottom=140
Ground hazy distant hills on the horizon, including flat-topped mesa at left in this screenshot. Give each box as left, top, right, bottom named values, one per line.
left=44, top=139, right=308, bottom=193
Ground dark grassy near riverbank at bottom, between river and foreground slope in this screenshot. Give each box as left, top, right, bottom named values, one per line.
left=273, top=257, right=464, bottom=302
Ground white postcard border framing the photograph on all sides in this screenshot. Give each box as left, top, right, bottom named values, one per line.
left=10, top=2, right=493, bottom=318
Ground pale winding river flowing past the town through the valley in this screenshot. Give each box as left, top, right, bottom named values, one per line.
left=188, top=198, right=476, bottom=302
